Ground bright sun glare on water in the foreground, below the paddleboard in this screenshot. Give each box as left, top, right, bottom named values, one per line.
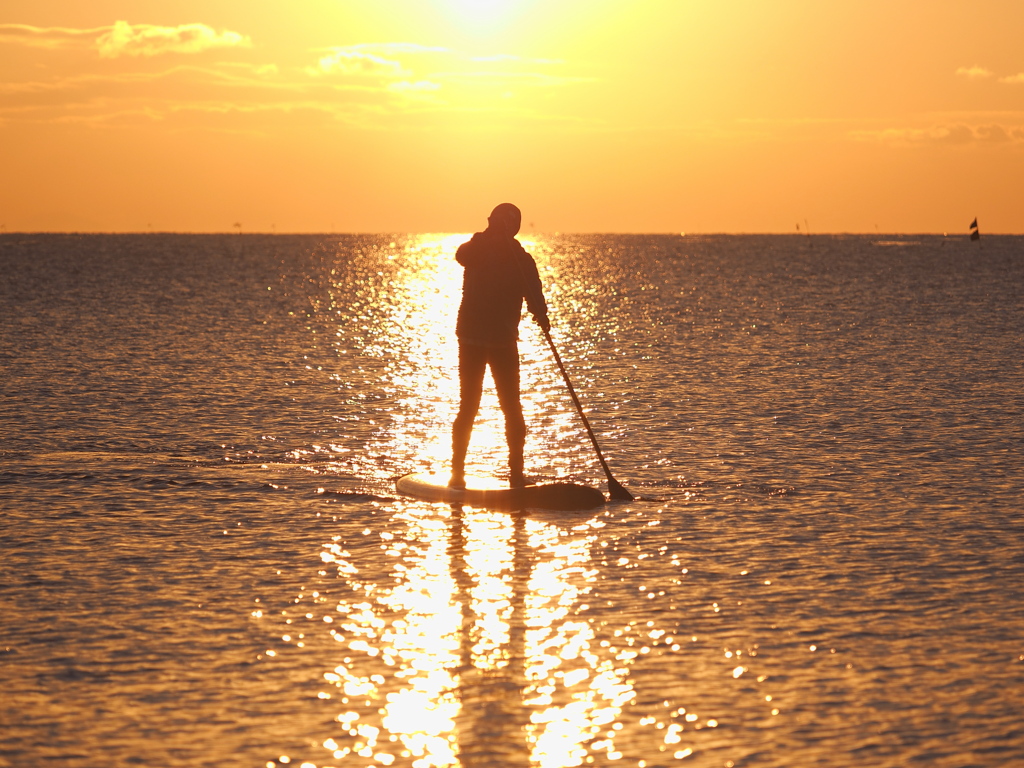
left=321, top=507, right=636, bottom=768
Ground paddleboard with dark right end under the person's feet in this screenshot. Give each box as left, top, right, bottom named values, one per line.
left=395, top=473, right=604, bottom=510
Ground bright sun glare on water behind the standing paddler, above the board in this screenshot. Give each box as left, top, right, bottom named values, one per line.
left=307, top=233, right=594, bottom=486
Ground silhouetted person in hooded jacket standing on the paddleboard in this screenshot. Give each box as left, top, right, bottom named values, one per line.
left=449, top=203, right=549, bottom=487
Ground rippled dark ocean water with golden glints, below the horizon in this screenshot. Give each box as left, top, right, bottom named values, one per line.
left=0, top=233, right=1024, bottom=768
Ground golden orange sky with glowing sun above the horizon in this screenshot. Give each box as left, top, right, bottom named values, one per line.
left=0, top=0, right=1024, bottom=232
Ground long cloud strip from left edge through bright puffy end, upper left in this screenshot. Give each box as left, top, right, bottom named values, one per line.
left=0, top=22, right=252, bottom=58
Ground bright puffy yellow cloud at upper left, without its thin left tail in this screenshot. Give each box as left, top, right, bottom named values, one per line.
left=96, top=22, right=252, bottom=58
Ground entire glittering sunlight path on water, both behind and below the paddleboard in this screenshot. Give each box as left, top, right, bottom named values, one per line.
left=276, top=236, right=720, bottom=768
